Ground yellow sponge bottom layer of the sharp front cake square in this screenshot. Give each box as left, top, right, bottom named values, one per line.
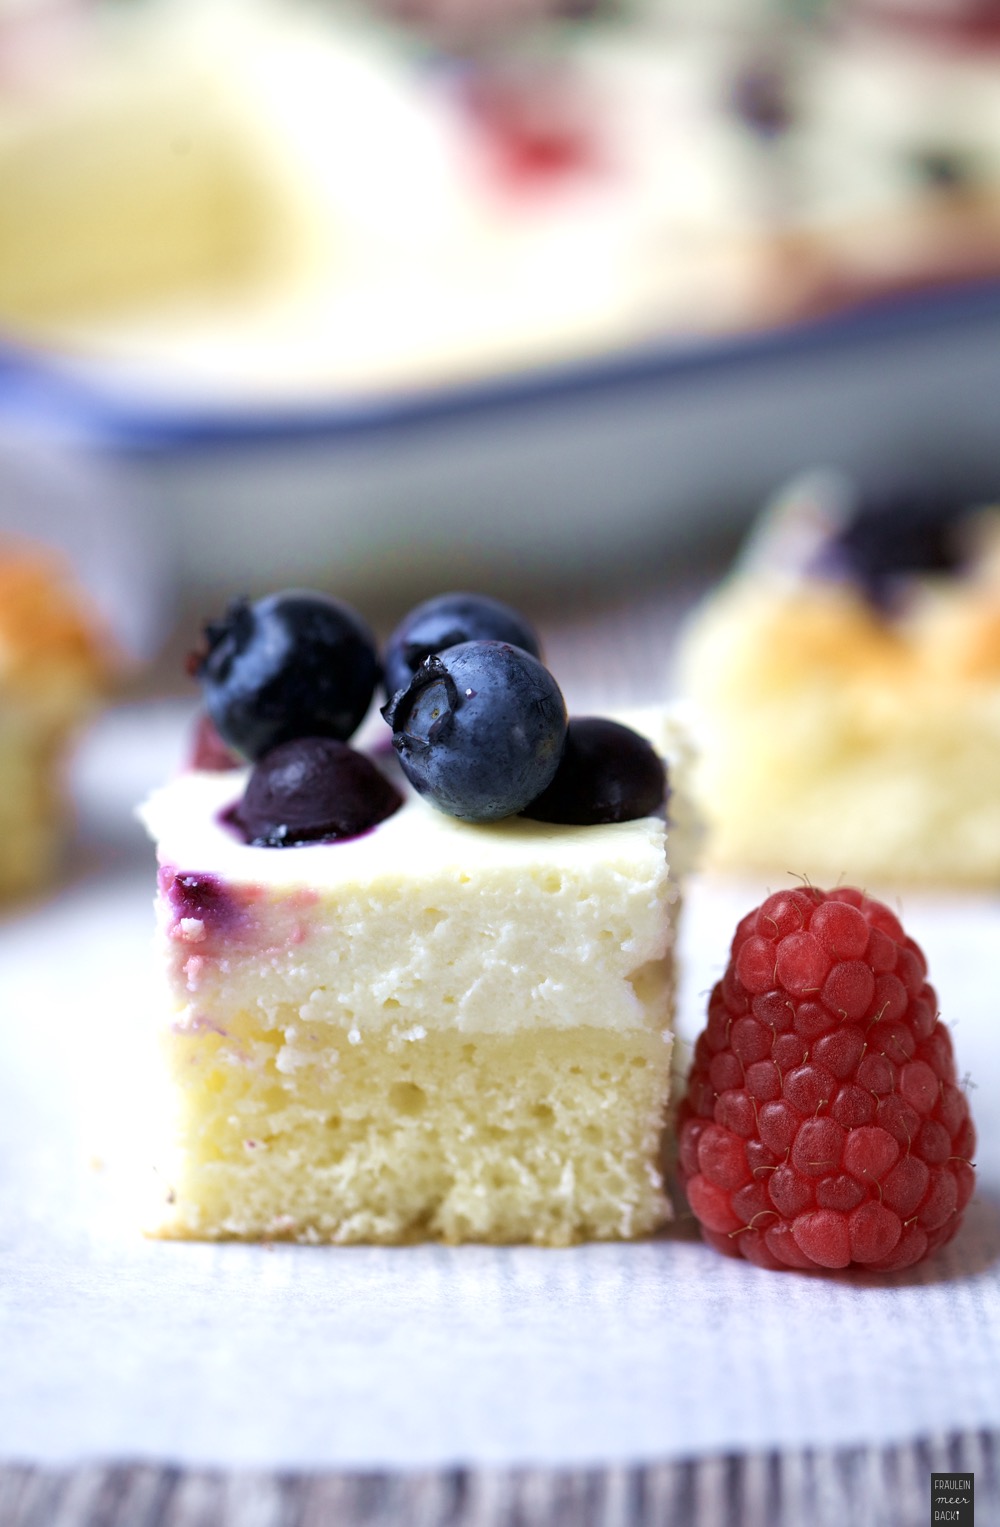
left=152, top=1003, right=670, bottom=1245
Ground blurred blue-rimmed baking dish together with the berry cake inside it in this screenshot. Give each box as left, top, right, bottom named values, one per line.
left=0, top=0, right=1000, bottom=683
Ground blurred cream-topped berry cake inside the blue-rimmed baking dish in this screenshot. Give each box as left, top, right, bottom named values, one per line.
left=0, top=0, right=1000, bottom=399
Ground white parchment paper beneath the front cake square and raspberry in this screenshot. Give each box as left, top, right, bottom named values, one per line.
left=0, top=707, right=1000, bottom=1467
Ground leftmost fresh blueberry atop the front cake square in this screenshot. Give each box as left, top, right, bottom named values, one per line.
left=192, top=589, right=379, bottom=759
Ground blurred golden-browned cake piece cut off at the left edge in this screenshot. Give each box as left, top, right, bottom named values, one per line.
left=0, top=542, right=111, bottom=901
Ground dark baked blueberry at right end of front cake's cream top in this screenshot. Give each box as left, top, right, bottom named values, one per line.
left=522, top=716, right=667, bottom=826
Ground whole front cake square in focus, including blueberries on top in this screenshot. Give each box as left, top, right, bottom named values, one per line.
left=144, top=592, right=687, bottom=1245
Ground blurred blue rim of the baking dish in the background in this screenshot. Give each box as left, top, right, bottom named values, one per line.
left=0, top=278, right=1000, bottom=454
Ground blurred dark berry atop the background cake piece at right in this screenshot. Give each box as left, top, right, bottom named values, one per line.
left=815, top=478, right=966, bottom=612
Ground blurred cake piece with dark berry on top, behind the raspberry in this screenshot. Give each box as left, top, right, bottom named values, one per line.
left=681, top=473, right=1000, bottom=886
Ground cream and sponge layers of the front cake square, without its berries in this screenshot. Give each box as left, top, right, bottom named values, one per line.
left=138, top=714, right=690, bottom=1245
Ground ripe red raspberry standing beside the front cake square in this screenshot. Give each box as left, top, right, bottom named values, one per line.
left=678, top=887, right=976, bottom=1272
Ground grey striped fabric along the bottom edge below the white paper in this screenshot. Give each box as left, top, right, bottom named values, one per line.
left=0, top=1432, right=1000, bottom=1527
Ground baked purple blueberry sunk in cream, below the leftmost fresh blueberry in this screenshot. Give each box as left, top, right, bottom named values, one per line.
left=229, top=738, right=403, bottom=847
